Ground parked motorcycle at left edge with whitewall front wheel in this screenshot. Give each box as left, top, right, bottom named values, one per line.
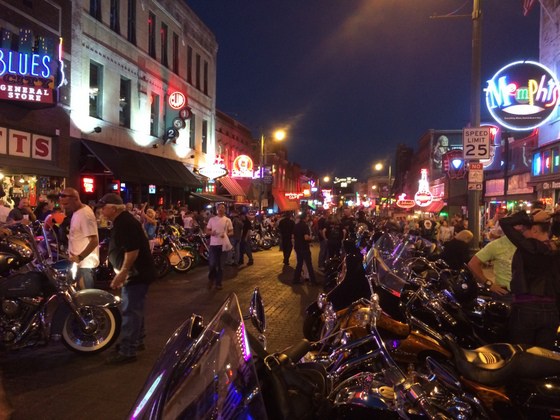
left=0, top=225, right=121, bottom=354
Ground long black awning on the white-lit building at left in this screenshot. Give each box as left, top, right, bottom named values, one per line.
left=82, top=140, right=202, bottom=187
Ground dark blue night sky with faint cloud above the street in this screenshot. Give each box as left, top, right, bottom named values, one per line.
left=186, top=0, right=540, bottom=177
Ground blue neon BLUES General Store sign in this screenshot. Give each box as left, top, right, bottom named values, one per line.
left=0, top=39, right=64, bottom=105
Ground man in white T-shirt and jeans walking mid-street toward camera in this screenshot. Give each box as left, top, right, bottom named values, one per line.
left=206, top=203, right=233, bottom=290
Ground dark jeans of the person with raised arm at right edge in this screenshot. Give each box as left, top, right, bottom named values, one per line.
left=509, top=303, right=559, bottom=350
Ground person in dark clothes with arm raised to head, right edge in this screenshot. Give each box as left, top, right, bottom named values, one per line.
left=500, top=209, right=560, bottom=350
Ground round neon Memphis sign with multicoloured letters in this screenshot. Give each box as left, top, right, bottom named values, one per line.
left=484, top=61, right=559, bottom=130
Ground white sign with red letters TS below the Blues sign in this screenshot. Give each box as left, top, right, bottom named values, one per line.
left=0, top=127, right=52, bottom=160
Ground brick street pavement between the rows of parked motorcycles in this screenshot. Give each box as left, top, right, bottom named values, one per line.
left=0, top=245, right=322, bottom=420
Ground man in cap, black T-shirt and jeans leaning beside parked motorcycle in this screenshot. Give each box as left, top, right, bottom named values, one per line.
left=98, top=193, right=156, bottom=364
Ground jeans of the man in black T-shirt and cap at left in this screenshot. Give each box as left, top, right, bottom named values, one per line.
left=119, top=283, right=149, bottom=356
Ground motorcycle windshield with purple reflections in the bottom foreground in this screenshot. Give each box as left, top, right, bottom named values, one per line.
left=129, top=294, right=267, bottom=419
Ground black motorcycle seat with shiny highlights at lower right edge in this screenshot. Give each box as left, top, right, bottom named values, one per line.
left=447, top=340, right=560, bottom=386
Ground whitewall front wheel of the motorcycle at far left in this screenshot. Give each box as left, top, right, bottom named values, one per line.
left=62, top=306, right=122, bottom=354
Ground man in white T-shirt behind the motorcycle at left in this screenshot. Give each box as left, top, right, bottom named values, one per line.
left=58, top=188, right=99, bottom=289
